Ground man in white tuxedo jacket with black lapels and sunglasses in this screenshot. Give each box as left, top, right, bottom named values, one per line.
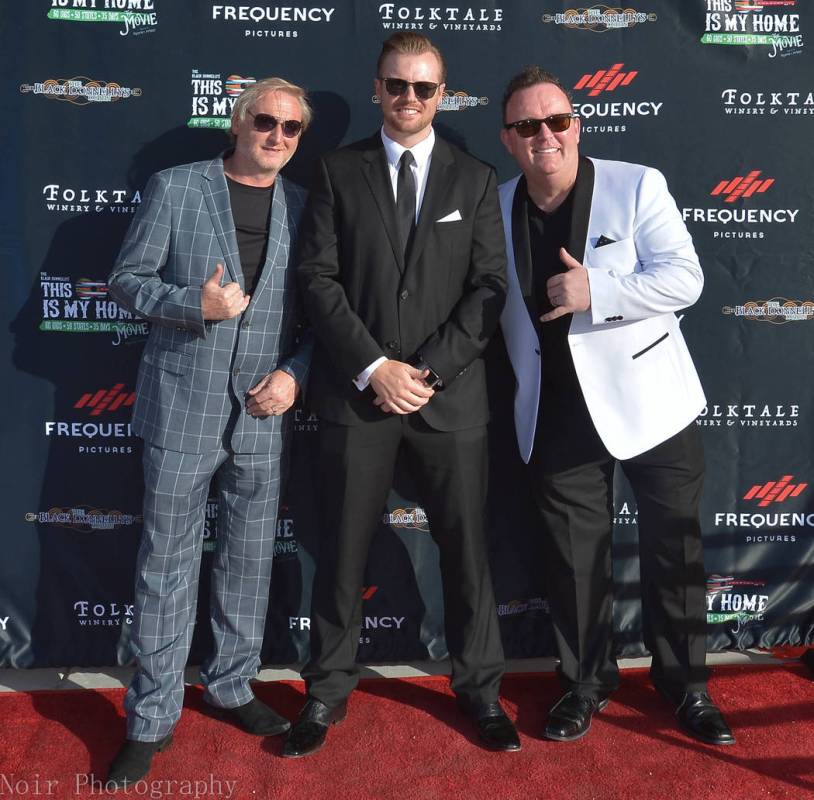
left=500, top=67, right=735, bottom=744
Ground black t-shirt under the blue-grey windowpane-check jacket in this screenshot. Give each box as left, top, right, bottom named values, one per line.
left=226, top=176, right=274, bottom=294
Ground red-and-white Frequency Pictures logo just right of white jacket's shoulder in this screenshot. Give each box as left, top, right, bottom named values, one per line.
left=681, top=169, right=800, bottom=239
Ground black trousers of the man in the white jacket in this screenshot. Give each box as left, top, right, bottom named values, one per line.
left=530, top=406, right=708, bottom=703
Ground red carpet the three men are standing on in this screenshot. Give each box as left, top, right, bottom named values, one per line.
left=0, top=664, right=814, bottom=800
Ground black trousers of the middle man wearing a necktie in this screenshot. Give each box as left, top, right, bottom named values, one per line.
left=303, top=414, right=504, bottom=706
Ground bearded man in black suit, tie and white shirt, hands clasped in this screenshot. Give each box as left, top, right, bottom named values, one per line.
left=283, top=32, right=520, bottom=757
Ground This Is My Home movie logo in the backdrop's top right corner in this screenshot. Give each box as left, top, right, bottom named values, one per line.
left=701, top=0, right=803, bottom=58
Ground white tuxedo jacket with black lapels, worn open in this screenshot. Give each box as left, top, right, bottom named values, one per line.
left=500, top=158, right=706, bottom=462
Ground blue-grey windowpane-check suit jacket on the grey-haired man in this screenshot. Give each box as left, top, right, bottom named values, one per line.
left=108, top=157, right=312, bottom=453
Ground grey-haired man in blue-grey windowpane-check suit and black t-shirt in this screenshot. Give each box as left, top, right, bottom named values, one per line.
left=108, top=78, right=311, bottom=787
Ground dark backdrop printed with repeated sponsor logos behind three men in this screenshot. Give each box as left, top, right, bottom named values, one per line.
left=0, top=0, right=814, bottom=667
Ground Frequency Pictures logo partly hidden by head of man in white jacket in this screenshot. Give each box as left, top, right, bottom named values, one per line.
left=574, top=63, right=664, bottom=133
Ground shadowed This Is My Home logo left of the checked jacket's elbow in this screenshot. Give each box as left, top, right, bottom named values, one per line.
left=39, top=272, right=149, bottom=346
